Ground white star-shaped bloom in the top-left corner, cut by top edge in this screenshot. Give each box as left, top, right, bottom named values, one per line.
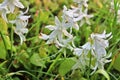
left=1, top=0, right=24, bottom=13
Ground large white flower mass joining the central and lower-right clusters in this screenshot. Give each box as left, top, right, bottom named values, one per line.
left=40, top=0, right=112, bottom=74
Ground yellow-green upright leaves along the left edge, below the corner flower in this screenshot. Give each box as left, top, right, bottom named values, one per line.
left=0, top=18, right=10, bottom=59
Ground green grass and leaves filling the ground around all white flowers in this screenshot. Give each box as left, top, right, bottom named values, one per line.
left=0, top=0, right=120, bottom=80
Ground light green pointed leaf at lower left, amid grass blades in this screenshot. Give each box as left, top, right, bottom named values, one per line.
left=30, top=53, right=46, bottom=67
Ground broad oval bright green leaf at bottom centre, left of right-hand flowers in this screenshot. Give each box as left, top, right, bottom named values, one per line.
left=59, top=58, right=75, bottom=76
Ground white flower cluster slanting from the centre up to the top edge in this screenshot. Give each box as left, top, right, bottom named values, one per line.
left=40, top=0, right=93, bottom=47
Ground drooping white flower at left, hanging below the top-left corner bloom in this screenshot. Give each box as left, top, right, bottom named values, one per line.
left=10, top=12, right=30, bottom=44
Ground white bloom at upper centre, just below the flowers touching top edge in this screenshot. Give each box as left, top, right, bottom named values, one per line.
left=63, top=6, right=93, bottom=26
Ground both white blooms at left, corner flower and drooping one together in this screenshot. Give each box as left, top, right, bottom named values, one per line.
left=0, top=0, right=30, bottom=44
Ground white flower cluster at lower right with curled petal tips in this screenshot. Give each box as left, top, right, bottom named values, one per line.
left=74, top=31, right=112, bottom=74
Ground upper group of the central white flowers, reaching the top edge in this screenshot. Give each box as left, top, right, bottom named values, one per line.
left=63, top=0, right=93, bottom=29
